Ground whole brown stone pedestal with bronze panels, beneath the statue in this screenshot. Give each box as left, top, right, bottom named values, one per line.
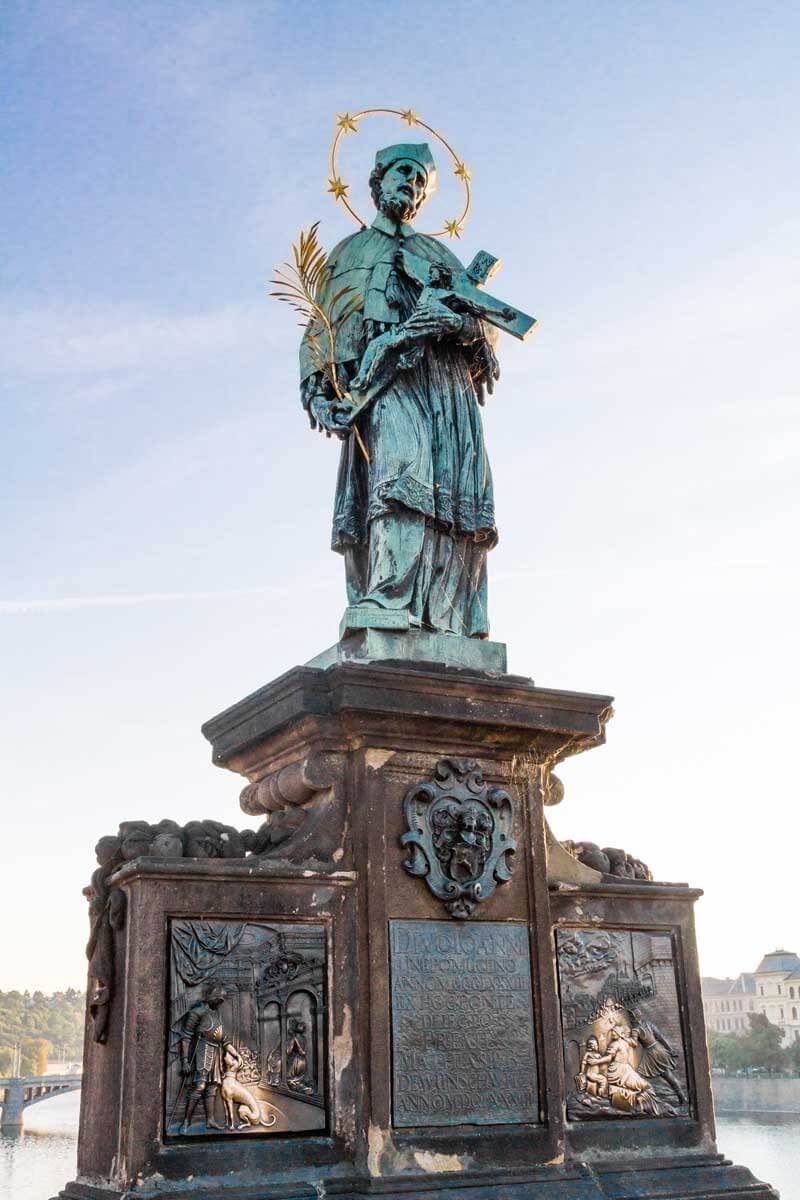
left=54, top=656, right=776, bottom=1200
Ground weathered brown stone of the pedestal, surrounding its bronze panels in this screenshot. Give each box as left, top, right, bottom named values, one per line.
left=57, top=662, right=775, bottom=1200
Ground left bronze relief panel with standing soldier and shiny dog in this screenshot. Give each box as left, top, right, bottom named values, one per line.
left=164, top=919, right=327, bottom=1138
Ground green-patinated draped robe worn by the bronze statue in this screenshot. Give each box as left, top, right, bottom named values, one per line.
left=300, top=214, right=497, bottom=637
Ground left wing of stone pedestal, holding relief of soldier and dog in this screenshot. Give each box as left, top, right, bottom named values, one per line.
left=65, top=858, right=361, bottom=1200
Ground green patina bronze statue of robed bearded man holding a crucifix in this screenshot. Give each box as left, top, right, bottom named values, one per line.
left=300, top=144, right=534, bottom=637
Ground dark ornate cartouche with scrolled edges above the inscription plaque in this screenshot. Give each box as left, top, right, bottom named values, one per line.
left=401, top=758, right=516, bottom=919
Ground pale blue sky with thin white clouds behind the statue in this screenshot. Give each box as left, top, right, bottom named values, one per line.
left=0, top=0, right=800, bottom=990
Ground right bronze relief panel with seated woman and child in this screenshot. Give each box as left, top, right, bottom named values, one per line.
left=555, top=928, right=688, bottom=1121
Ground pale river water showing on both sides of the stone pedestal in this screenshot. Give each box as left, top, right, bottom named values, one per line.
left=0, top=1092, right=800, bottom=1200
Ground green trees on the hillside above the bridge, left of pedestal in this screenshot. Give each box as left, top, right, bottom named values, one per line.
left=0, top=988, right=85, bottom=1075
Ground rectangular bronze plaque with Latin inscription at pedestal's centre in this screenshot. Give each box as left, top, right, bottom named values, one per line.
left=389, top=920, right=539, bottom=1127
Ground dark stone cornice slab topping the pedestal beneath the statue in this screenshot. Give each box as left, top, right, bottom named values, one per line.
left=203, top=662, right=613, bottom=780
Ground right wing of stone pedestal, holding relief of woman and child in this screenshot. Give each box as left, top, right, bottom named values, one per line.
left=551, top=880, right=714, bottom=1166
